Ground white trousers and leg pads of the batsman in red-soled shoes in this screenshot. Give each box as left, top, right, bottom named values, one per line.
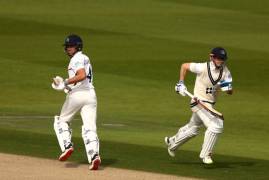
left=54, top=89, right=99, bottom=163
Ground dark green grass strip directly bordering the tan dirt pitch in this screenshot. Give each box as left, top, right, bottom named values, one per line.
left=0, top=129, right=269, bottom=179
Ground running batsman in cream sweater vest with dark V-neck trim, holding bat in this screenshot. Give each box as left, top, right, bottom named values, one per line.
left=165, top=47, right=232, bottom=164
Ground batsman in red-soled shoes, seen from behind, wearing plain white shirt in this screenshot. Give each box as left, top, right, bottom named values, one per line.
left=52, top=34, right=101, bottom=170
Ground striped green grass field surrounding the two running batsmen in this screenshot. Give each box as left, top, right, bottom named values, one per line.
left=0, top=0, right=269, bottom=179
